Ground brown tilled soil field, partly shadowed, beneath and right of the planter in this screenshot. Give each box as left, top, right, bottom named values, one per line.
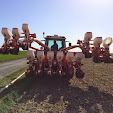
left=10, top=59, right=113, bottom=113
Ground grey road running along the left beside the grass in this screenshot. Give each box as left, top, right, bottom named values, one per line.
left=0, top=58, right=27, bottom=79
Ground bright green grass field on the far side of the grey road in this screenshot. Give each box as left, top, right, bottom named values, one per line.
left=0, top=51, right=27, bottom=63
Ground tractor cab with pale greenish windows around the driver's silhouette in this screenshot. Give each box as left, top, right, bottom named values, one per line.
left=45, top=35, right=66, bottom=51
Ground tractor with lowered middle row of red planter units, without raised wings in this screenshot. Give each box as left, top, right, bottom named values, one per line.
left=26, top=35, right=84, bottom=79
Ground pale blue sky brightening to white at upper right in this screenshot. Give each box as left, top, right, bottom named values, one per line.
left=0, top=0, right=113, bottom=53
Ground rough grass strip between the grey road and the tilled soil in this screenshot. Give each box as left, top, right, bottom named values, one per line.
left=0, top=66, right=31, bottom=113
